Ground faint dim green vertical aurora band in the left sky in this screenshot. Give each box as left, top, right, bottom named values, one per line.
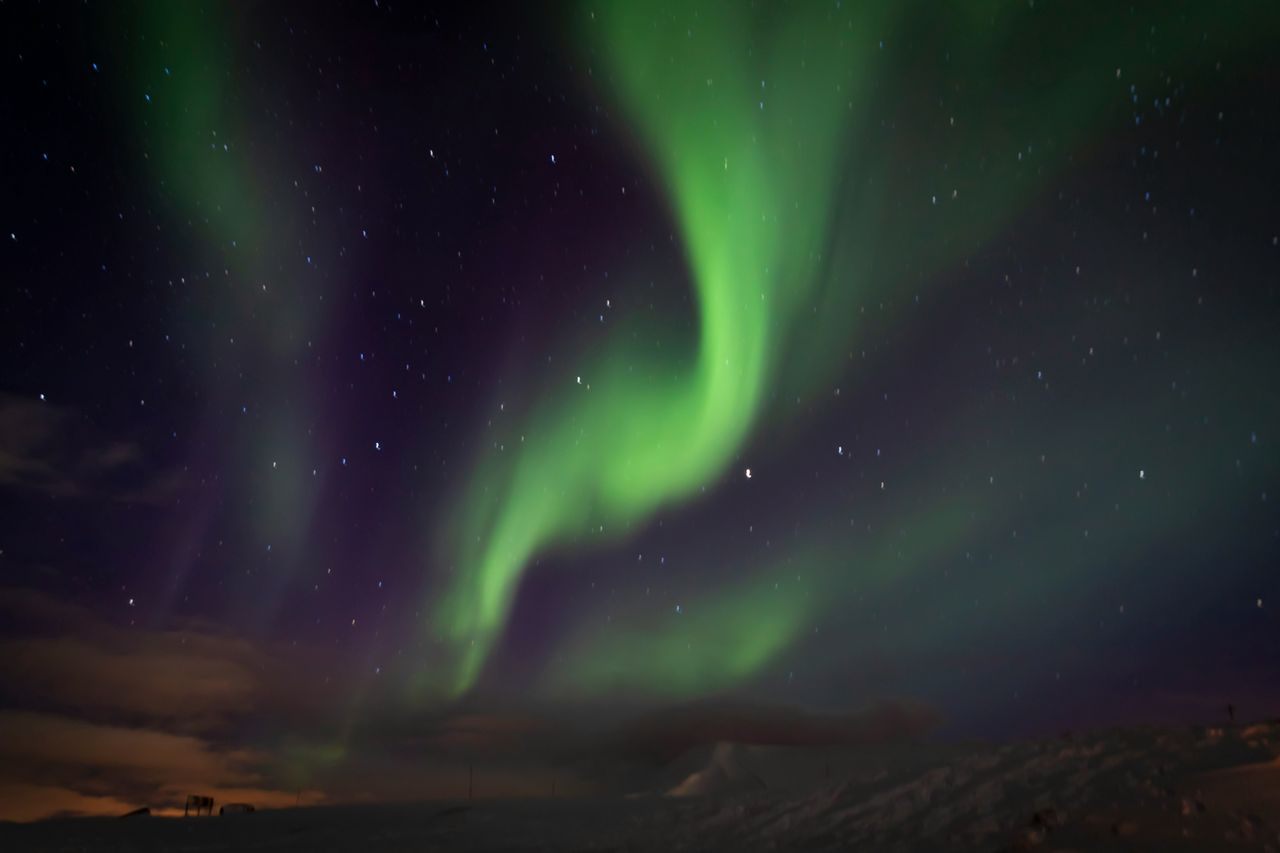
left=121, top=3, right=328, bottom=578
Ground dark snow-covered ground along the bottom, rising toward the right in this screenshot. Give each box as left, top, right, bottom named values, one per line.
left=0, top=721, right=1280, bottom=853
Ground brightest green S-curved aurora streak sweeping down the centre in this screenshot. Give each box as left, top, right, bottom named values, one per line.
left=436, top=5, right=875, bottom=692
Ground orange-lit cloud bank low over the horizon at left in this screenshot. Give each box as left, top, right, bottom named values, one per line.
left=0, top=589, right=323, bottom=820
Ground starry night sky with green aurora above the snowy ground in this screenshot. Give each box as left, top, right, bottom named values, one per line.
left=0, top=0, right=1280, bottom=817
